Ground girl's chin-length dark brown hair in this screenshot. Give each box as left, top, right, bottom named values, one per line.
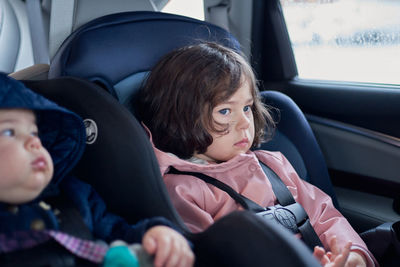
left=139, top=42, right=275, bottom=159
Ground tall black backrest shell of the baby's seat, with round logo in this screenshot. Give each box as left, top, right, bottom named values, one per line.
left=23, top=77, right=186, bottom=229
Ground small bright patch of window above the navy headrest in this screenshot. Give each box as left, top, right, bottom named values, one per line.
left=162, top=0, right=204, bottom=20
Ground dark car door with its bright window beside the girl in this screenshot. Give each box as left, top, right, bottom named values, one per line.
left=252, top=0, right=400, bottom=234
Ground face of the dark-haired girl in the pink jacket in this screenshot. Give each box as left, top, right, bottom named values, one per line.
left=194, top=80, right=254, bottom=163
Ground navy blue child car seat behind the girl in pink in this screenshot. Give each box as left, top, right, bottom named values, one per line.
left=49, top=9, right=337, bottom=206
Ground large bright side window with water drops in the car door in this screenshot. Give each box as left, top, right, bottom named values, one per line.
left=280, top=0, right=400, bottom=84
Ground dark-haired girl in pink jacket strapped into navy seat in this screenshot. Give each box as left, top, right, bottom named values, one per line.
left=139, top=43, right=376, bottom=266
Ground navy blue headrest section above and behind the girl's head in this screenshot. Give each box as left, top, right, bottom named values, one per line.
left=49, top=11, right=240, bottom=111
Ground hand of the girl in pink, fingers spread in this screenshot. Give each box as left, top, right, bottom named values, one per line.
left=314, top=236, right=350, bottom=267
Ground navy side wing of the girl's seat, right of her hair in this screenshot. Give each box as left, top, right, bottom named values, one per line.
left=260, top=91, right=339, bottom=208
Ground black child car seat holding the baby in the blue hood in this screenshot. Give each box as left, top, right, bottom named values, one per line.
left=24, top=77, right=320, bottom=267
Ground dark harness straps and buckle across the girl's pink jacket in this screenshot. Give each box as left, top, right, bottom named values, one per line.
left=168, top=161, right=323, bottom=250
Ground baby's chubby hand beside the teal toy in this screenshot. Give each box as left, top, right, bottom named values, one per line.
left=142, top=226, right=194, bottom=267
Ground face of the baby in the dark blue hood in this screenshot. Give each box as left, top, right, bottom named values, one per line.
left=0, top=109, right=53, bottom=204
